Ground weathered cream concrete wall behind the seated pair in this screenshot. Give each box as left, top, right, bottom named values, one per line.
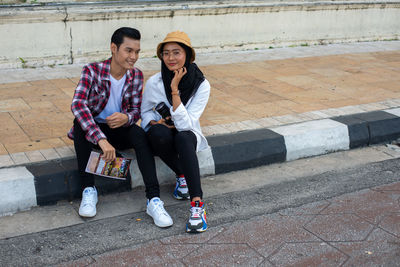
left=0, top=1, right=400, bottom=68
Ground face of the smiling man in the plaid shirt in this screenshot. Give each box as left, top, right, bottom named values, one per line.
left=111, top=37, right=140, bottom=69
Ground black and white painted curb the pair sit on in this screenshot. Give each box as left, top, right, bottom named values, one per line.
left=0, top=108, right=400, bottom=216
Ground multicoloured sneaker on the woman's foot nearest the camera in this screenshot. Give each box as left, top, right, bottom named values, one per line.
left=186, top=201, right=208, bottom=233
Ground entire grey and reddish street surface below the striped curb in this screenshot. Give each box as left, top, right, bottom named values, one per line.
left=0, top=146, right=400, bottom=266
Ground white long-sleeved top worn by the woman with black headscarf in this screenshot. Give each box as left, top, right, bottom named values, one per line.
left=141, top=72, right=210, bottom=151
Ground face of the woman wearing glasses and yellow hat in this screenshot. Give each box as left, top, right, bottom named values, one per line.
left=161, top=43, right=186, bottom=71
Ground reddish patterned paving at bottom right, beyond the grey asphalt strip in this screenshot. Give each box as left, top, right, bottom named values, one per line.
left=59, top=182, right=400, bottom=266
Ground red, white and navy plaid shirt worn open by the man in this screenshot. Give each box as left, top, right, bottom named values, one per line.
left=68, top=58, right=143, bottom=145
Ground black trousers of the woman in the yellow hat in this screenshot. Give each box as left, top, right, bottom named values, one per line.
left=147, top=124, right=203, bottom=199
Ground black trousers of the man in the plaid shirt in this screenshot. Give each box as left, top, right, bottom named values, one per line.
left=74, top=119, right=160, bottom=199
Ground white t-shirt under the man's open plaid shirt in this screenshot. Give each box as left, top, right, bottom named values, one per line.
left=94, top=74, right=126, bottom=123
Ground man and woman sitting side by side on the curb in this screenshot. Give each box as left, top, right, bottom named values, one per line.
left=68, top=27, right=210, bottom=232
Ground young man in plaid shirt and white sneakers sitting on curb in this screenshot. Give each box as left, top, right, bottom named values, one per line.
left=68, top=27, right=173, bottom=227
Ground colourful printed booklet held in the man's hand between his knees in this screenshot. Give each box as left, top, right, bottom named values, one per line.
left=85, top=151, right=132, bottom=180
